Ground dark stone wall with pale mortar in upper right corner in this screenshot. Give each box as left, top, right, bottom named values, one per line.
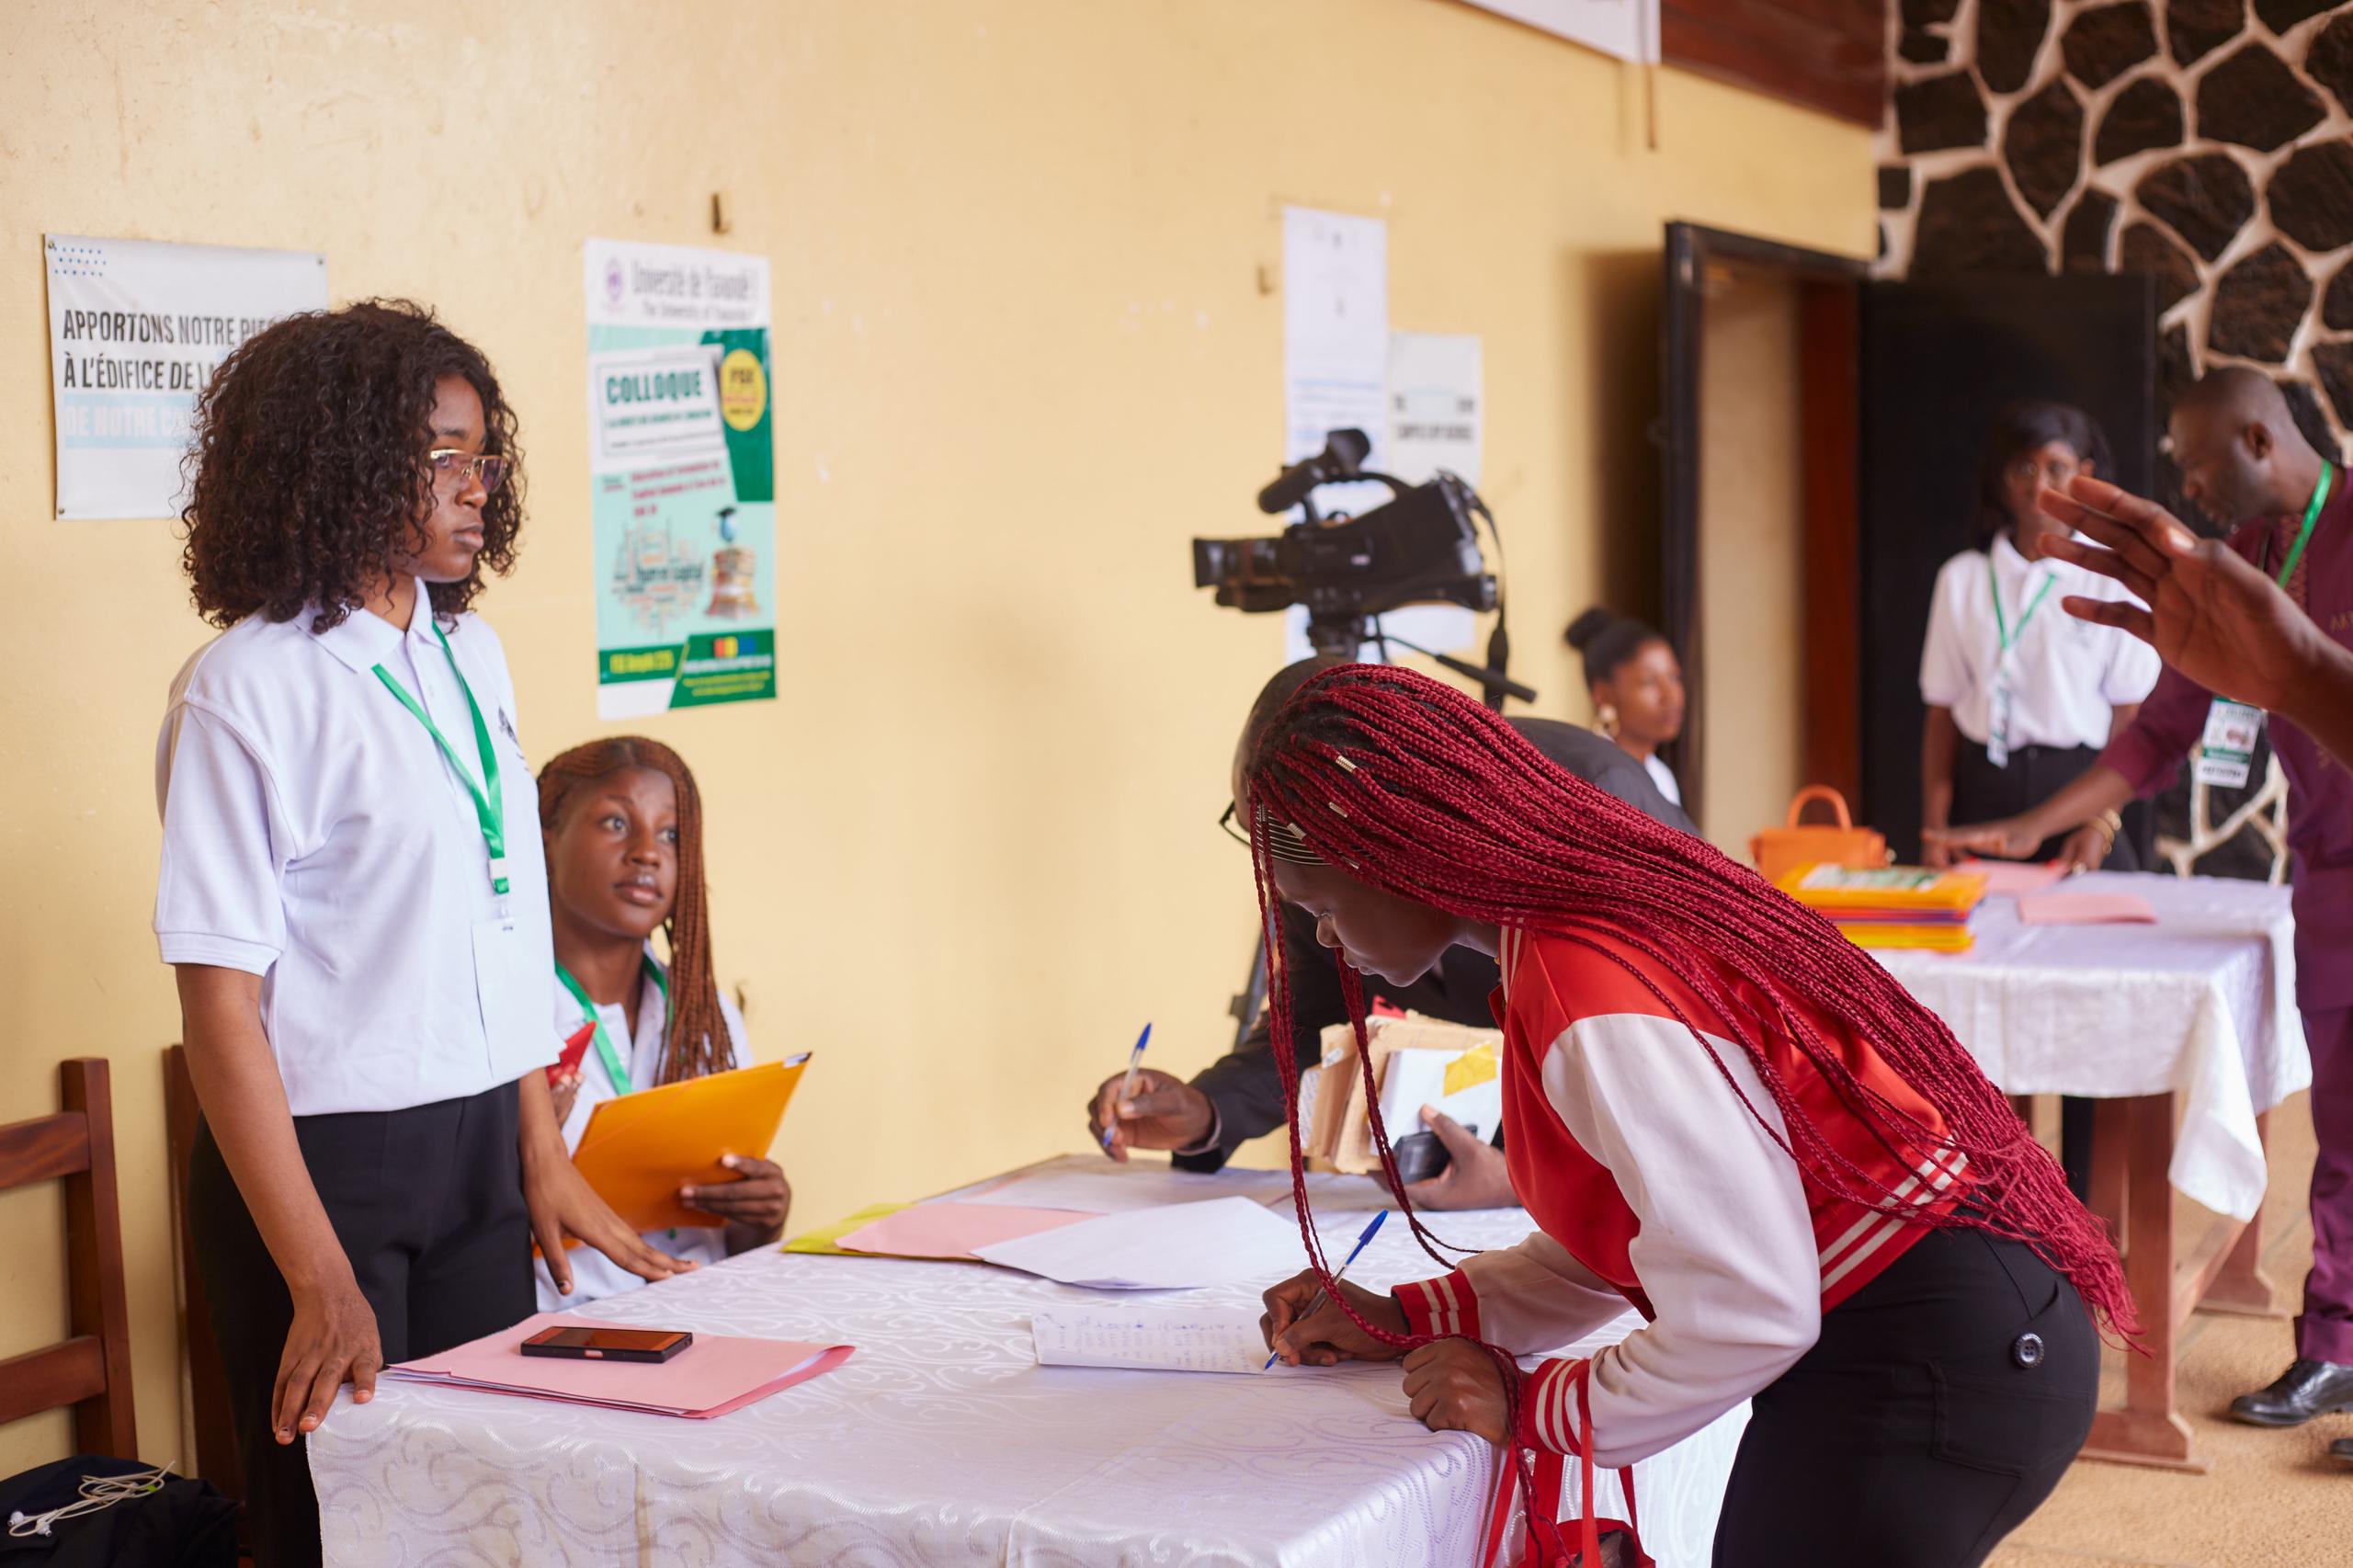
left=1880, top=0, right=2353, bottom=463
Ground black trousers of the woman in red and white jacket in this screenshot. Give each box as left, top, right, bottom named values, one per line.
left=1715, top=1229, right=2099, bottom=1568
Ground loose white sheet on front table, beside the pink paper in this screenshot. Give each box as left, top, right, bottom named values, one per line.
left=972, top=1199, right=1306, bottom=1290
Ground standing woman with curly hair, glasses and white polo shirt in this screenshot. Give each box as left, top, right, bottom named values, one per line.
left=155, top=301, right=682, bottom=1568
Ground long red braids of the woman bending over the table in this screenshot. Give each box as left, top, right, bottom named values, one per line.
left=1245, top=664, right=2139, bottom=1346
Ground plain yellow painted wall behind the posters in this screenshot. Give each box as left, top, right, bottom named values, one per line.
left=0, top=0, right=1870, bottom=1474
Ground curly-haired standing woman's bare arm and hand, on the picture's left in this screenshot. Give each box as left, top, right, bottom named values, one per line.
left=172, top=963, right=383, bottom=1443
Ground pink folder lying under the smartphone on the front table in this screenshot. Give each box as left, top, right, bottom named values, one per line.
left=383, top=1312, right=852, bottom=1420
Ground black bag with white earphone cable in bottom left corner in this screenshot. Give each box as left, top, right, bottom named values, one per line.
left=0, top=1452, right=238, bottom=1568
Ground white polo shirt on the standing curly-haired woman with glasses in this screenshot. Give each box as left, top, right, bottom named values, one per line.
left=155, top=584, right=558, bottom=1116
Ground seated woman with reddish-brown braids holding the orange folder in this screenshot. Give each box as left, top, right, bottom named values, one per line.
left=539, top=734, right=793, bottom=1312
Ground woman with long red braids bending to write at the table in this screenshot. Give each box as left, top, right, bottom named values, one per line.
left=1235, top=666, right=2134, bottom=1568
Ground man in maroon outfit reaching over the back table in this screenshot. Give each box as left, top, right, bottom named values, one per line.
left=1946, top=368, right=2353, bottom=1426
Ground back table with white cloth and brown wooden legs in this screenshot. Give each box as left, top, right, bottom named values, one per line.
left=1875, top=871, right=2313, bottom=1467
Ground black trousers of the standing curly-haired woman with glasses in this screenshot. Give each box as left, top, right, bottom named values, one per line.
left=188, top=1083, right=537, bottom=1568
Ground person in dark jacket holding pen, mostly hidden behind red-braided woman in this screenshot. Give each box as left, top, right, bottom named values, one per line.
left=1087, top=659, right=1694, bottom=1208
